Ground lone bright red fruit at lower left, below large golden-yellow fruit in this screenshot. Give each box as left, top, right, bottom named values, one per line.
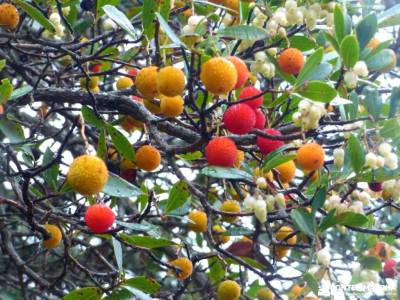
left=85, top=204, right=115, bottom=233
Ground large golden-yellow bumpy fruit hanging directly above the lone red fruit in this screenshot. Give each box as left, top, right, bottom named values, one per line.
left=67, top=155, right=108, bottom=196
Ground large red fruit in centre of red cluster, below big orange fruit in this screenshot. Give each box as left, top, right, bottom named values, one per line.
left=224, top=103, right=256, bottom=134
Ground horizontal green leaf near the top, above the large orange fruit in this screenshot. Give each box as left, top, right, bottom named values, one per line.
left=217, top=25, right=268, bottom=41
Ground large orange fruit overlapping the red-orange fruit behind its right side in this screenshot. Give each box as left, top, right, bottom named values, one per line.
left=200, top=57, right=237, bottom=95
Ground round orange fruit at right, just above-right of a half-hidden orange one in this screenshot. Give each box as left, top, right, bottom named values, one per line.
left=296, top=143, right=325, bottom=171
